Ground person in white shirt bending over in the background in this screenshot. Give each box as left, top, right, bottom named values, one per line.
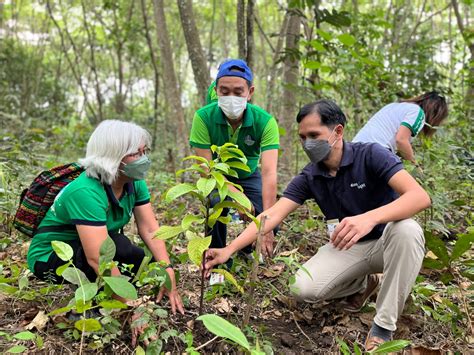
left=352, top=91, right=448, bottom=164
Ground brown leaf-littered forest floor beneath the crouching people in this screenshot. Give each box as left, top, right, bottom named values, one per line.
left=0, top=204, right=474, bottom=354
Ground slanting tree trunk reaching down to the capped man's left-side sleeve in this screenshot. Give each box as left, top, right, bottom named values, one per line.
left=153, top=0, right=189, bottom=157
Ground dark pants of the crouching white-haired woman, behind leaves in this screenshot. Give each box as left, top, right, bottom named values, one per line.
left=34, top=233, right=145, bottom=283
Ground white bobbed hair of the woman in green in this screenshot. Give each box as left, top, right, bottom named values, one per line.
left=79, top=120, right=151, bottom=185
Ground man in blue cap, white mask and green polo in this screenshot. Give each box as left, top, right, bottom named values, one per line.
left=190, top=59, right=279, bottom=255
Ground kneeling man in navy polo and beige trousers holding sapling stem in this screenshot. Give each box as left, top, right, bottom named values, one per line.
left=206, top=100, right=431, bottom=351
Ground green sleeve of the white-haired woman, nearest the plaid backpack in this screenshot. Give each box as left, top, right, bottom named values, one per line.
left=63, top=190, right=108, bottom=226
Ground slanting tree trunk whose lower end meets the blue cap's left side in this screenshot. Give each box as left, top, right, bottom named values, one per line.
left=178, top=0, right=211, bottom=105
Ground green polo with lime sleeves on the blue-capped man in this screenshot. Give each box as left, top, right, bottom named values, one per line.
left=189, top=102, right=280, bottom=179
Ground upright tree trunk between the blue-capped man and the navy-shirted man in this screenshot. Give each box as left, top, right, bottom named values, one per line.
left=279, top=12, right=301, bottom=179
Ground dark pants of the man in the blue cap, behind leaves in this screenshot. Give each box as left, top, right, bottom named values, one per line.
left=210, top=170, right=278, bottom=254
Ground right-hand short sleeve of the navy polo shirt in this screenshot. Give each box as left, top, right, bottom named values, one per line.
left=369, top=143, right=404, bottom=184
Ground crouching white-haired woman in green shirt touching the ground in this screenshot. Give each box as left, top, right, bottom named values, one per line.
left=27, top=120, right=184, bottom=313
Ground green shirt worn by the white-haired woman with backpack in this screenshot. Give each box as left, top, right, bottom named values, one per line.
left=27, top=172, right=150, bottom=271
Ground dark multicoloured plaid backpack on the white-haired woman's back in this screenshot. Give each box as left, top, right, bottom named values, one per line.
left=13, top=163, right=84, bottom=237
